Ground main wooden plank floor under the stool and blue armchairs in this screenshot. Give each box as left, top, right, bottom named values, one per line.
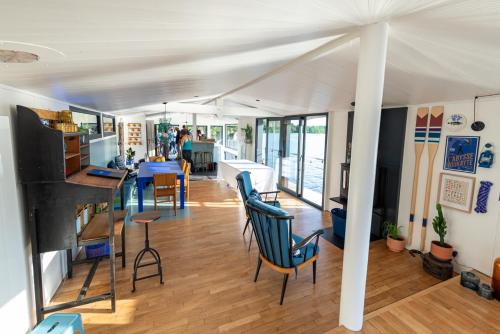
left=48, top=181, right=437, bottom=334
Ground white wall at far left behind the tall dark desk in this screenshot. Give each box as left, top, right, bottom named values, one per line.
left=0, top=85, right=111, bottom=333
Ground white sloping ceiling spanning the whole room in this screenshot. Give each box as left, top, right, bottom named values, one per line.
left=0, top=0, right=500, bottom=115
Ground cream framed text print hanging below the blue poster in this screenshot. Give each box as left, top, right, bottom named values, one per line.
left=438, top=173, right=476, bottom=212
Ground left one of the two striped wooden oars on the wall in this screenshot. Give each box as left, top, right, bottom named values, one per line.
left=407, top=108, right=429, bottom=245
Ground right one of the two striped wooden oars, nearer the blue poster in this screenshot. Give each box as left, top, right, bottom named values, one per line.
left=420, top=106, right=444, bottom=251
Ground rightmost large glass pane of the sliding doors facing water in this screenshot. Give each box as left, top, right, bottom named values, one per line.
left=302, top=115, right=327, bottom=206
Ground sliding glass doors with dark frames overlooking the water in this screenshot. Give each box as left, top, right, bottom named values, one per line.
left=255, top=114, right=328, bottom=208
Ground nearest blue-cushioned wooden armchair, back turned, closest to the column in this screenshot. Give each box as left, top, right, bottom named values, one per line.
left=246, top=195, right=323, bottom=305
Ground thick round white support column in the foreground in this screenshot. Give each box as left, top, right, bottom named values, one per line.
left=340, top=22, right=389, bottom=331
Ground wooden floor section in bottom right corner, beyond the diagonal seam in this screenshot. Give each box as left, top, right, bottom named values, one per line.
left=330, top=275, right=500, bottom=334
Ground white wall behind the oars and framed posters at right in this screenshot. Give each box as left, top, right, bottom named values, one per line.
left=399, top=97, right=500, bottom=275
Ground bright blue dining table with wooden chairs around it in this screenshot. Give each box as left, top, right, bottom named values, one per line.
left=137, top=161, right=184, bottom=212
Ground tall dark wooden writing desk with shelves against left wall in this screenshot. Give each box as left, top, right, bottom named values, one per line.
left=16, top=106, right=127, bottom=322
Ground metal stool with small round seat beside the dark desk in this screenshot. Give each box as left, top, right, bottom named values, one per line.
left=130, top=211, right=163, bottom=292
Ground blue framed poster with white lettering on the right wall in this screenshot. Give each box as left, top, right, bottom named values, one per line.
left=443, top=136, right=479, bottom=174
